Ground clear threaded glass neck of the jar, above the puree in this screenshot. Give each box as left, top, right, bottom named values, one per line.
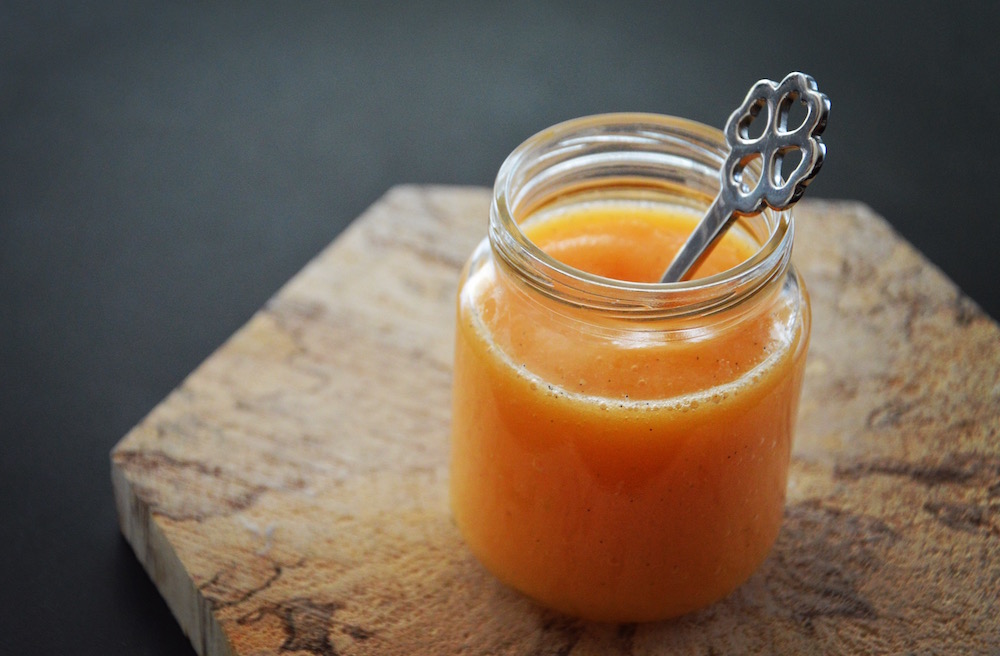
left=489, top=114, right=794, bottom=320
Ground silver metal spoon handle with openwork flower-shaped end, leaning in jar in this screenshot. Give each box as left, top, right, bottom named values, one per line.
left=661, top=73, right=830, bottom=282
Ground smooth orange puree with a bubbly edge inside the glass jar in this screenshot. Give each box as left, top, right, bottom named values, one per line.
left=451, top=202, right=808, bottom=621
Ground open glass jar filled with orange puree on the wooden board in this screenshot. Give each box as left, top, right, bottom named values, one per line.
left=450, top=114, right=810, bottom=622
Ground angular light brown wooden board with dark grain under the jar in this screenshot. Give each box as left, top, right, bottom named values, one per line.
left=111, top=186, right=1000, bottom=656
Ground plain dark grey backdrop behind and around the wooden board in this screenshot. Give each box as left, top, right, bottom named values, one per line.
left=0, top=0, right=1000, bottom=654
